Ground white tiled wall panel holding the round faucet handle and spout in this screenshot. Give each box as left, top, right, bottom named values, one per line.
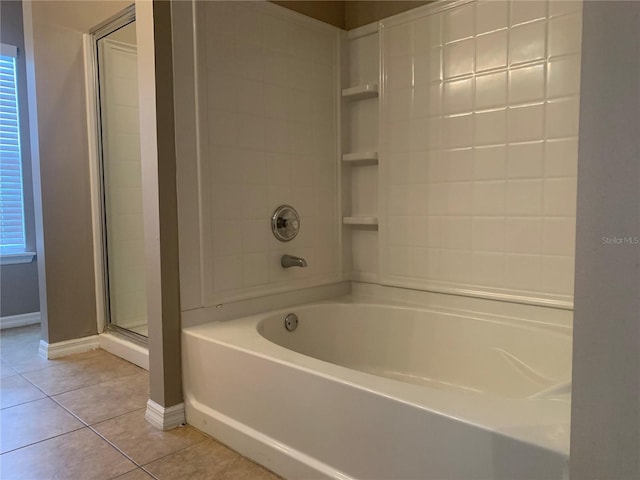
left=197, top=2, right=341, bottom=306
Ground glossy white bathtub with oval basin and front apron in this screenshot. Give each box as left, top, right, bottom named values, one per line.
left=183, top=300, right=571, bottom=480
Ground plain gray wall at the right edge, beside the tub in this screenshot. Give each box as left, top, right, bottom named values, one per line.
left=570, top=1, right=640, bottom=480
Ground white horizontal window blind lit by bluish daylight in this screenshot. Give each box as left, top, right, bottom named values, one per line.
left=0, top=44, right=25, bottom=254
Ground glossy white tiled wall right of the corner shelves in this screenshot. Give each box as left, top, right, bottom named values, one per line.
left=379, top=0, right=582, bottom=304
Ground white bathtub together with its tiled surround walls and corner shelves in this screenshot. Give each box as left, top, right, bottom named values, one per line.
left=172, top=0, right=582, bottom=479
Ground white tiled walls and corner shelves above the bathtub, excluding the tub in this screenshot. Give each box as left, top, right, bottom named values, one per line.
left=172, top=0, right=582, bottom=322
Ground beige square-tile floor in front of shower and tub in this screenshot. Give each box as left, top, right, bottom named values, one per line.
left=0, top=326, right=280, bottom=480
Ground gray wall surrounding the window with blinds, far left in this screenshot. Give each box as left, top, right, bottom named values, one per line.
left=0, top=0, right=40, bottom=317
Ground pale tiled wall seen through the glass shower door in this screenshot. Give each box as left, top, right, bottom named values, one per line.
left=100, top=40, right=147, bottom=328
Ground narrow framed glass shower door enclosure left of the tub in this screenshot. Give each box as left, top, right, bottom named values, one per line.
left=91, top=5, right=148, bottom=342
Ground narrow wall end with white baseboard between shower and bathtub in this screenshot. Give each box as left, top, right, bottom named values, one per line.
left=136, top=0, right=184, bottom=429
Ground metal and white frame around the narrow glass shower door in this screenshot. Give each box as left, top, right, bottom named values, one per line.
left=84, top=4, right=148, bottom=347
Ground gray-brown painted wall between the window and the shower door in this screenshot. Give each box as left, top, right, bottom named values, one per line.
left=25, top=0, right=128, bottom=343
